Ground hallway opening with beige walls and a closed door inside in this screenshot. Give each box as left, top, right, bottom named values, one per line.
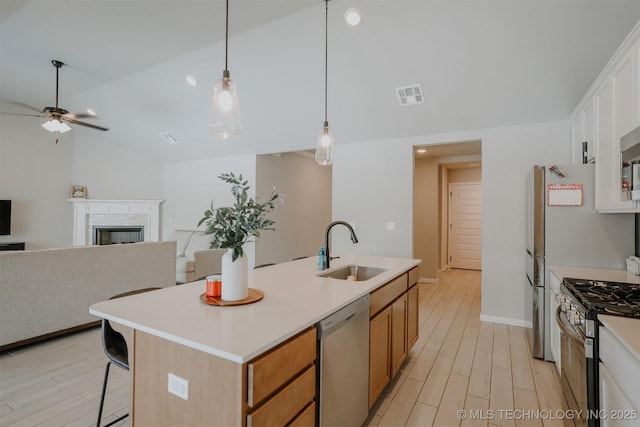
left=413, top=140, right=482, bottom=283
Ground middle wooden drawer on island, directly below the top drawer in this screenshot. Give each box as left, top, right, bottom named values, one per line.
left=247, top=365, right=316, bottom=427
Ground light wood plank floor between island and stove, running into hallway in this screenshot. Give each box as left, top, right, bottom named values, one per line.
left=367, top=270, right=573, bottom=427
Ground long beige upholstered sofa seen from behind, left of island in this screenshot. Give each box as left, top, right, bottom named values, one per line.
left=0, top=242, right=176, bottom=351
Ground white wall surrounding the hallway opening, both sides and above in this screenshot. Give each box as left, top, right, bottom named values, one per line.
left=332, top=121, right=571, bottom=325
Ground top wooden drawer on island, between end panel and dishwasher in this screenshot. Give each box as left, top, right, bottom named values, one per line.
left=247, top=327, right=316, bottom=407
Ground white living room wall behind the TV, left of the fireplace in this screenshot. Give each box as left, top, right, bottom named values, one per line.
left=0, top=113, right=74, bottom=249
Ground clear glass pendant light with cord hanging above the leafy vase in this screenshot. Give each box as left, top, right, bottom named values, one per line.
left=209, top=0, right=242, bottom=139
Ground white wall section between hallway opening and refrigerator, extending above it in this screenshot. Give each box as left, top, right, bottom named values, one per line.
left=481, top=121, right=571, bottom=325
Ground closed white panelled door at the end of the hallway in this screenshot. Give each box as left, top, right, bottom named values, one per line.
left=449, top=183, right=482, bottom=270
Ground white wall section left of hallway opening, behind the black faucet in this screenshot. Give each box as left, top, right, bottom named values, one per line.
left=331, top=140, right=417, bottom=257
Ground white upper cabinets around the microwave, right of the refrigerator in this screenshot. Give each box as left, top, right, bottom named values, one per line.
left=571, top=22, right=640, bottom=212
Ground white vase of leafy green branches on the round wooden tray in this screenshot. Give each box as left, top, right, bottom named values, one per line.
left=198, top=173, right=283, bottom=301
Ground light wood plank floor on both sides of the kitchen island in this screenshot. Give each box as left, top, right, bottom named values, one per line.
left=0, top=270, right=562, bottom=427
